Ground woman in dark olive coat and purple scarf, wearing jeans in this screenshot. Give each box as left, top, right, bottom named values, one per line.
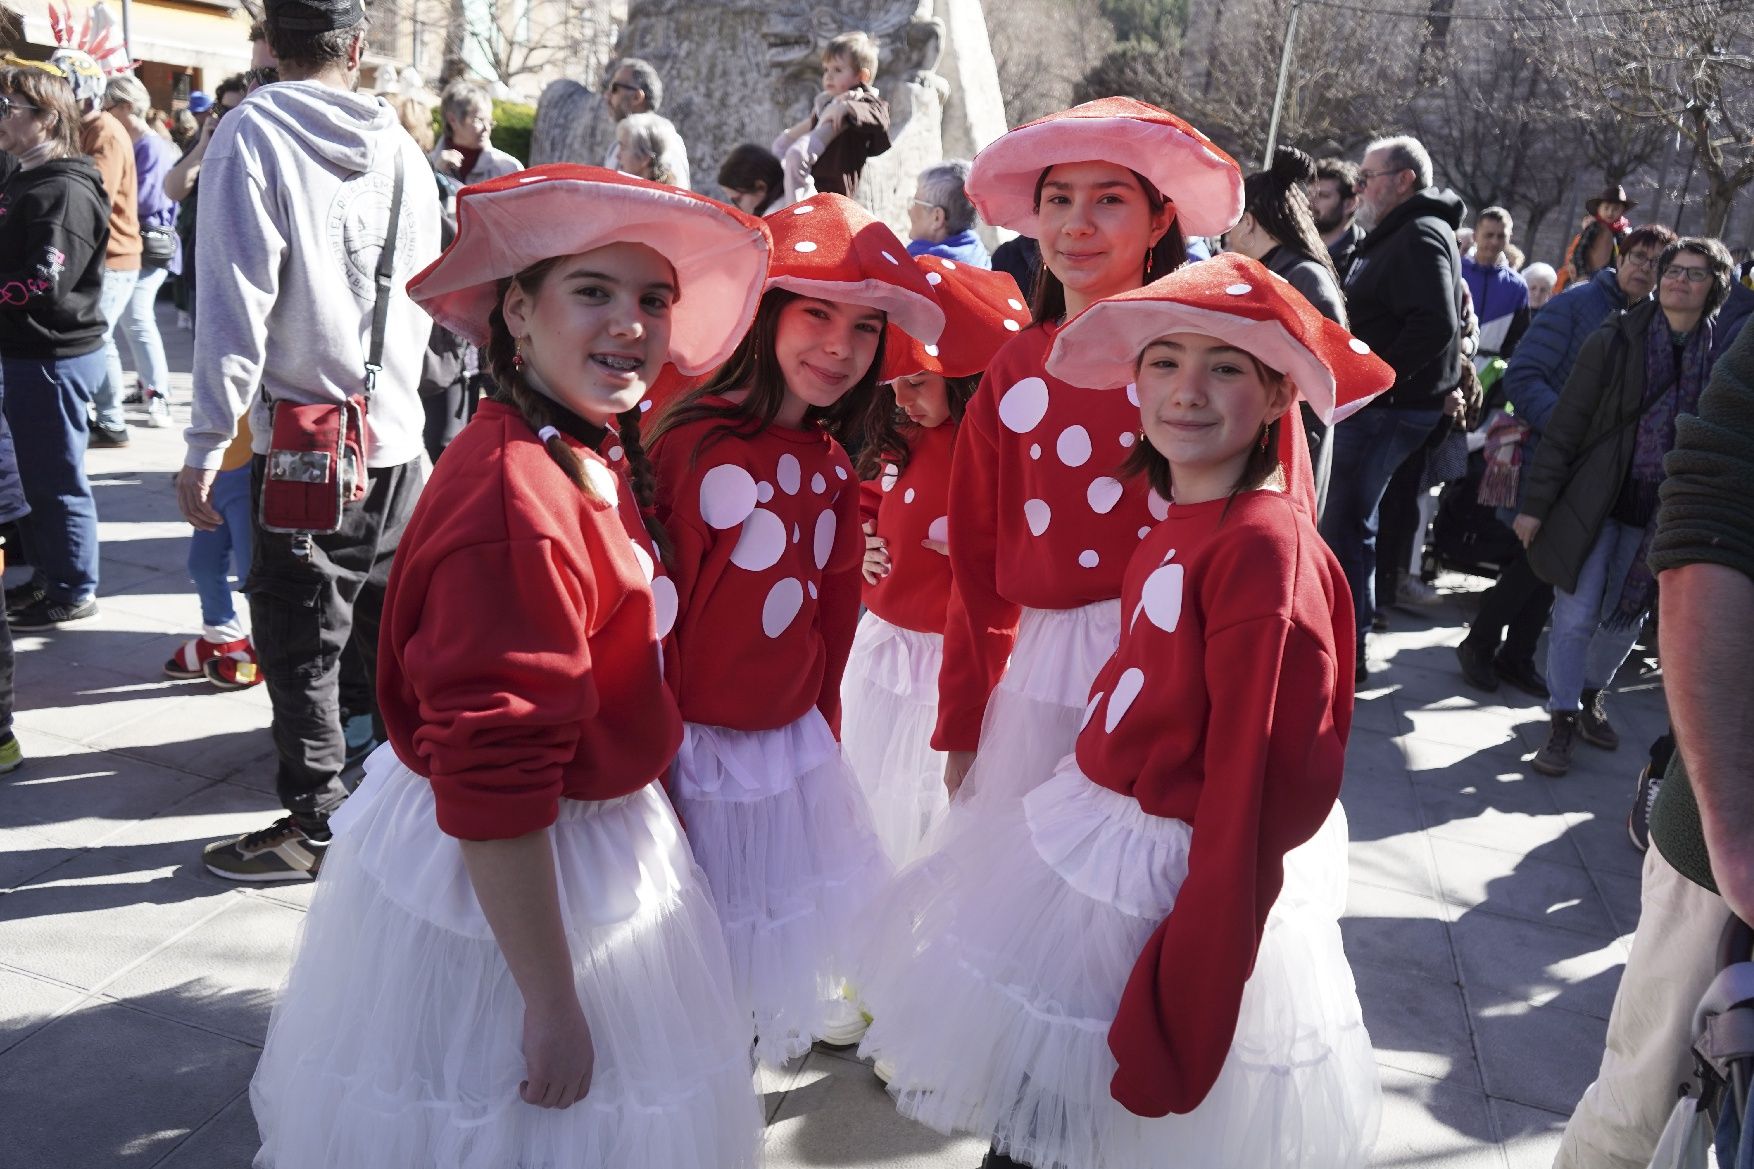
left=1515, top=237, right=1731, bottom=776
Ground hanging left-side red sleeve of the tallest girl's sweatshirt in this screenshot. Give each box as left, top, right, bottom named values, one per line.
left=931, top=376, right=1021, bottom=751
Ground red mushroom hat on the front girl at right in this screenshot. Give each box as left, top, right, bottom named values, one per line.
left=1047, top=253, right=1394, bottom=425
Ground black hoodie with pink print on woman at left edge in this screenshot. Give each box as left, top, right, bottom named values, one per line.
left=0, top=154, right=109, bottom=358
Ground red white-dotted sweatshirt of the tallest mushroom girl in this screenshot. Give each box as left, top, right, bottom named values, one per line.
left=931, top=325, right=1168, bottom=751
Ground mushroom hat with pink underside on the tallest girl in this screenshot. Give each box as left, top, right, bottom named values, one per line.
left=965, top=98, right=1242, bottom=237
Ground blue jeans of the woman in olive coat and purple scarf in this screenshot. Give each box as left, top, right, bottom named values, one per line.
left=1547, top=520, right=1643, bottom=711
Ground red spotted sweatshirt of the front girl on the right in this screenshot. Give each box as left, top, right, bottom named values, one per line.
left=1077, top=490, right=1352, bottom=1116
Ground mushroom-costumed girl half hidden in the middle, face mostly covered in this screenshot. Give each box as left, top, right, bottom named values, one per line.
left=840, top=256, right=1030, bottom=865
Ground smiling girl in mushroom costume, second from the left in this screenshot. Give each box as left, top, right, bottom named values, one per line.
left=652, top=195, right=944, bottom=1065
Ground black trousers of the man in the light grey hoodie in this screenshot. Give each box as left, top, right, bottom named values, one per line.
left=247, top=455, right=421, bottom=825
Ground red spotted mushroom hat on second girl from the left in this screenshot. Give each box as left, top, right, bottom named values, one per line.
left=766, top=193, right=944, bottom=344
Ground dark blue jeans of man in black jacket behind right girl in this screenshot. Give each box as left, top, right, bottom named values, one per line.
left=1321, top=405, right=1442, bottom=651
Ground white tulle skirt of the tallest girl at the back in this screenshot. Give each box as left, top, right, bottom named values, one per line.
left=947, top=600, right=1121, bottom=817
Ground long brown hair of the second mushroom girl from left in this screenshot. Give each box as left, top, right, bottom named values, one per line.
left=652, top=288, right=888, bottom=458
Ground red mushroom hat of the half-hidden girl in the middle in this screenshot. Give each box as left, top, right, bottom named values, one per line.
left=881, top=256, right=1030, bottom=381
